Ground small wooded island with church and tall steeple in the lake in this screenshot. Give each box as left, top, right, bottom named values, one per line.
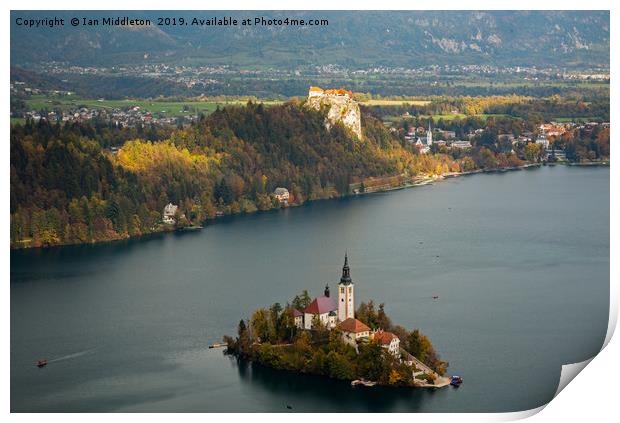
left=224, top=254, right=450, bottom=388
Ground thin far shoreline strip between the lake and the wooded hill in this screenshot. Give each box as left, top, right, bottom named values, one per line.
left=10, top=161, right=610, bottom=251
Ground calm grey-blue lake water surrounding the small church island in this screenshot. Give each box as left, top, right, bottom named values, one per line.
left=11, top=166, right=609, bottom=412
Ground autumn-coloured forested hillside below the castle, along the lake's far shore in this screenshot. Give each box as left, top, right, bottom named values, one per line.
left=11, top=103, right=457, bottom=248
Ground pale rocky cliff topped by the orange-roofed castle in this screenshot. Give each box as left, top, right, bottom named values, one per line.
left=308, top=87, right=362, bottom=141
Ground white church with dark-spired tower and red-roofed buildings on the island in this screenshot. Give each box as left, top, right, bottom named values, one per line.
left=293, top=254, right=400, bottom=357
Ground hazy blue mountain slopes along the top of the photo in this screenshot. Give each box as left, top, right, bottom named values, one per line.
left=11, top=11, right=610, bottom=69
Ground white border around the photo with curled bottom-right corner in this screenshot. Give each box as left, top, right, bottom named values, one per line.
left=0, top=0, right=620, bottom=423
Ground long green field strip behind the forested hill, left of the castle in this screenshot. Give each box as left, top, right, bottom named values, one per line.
left=26, top=96, right=280, bottom=117
